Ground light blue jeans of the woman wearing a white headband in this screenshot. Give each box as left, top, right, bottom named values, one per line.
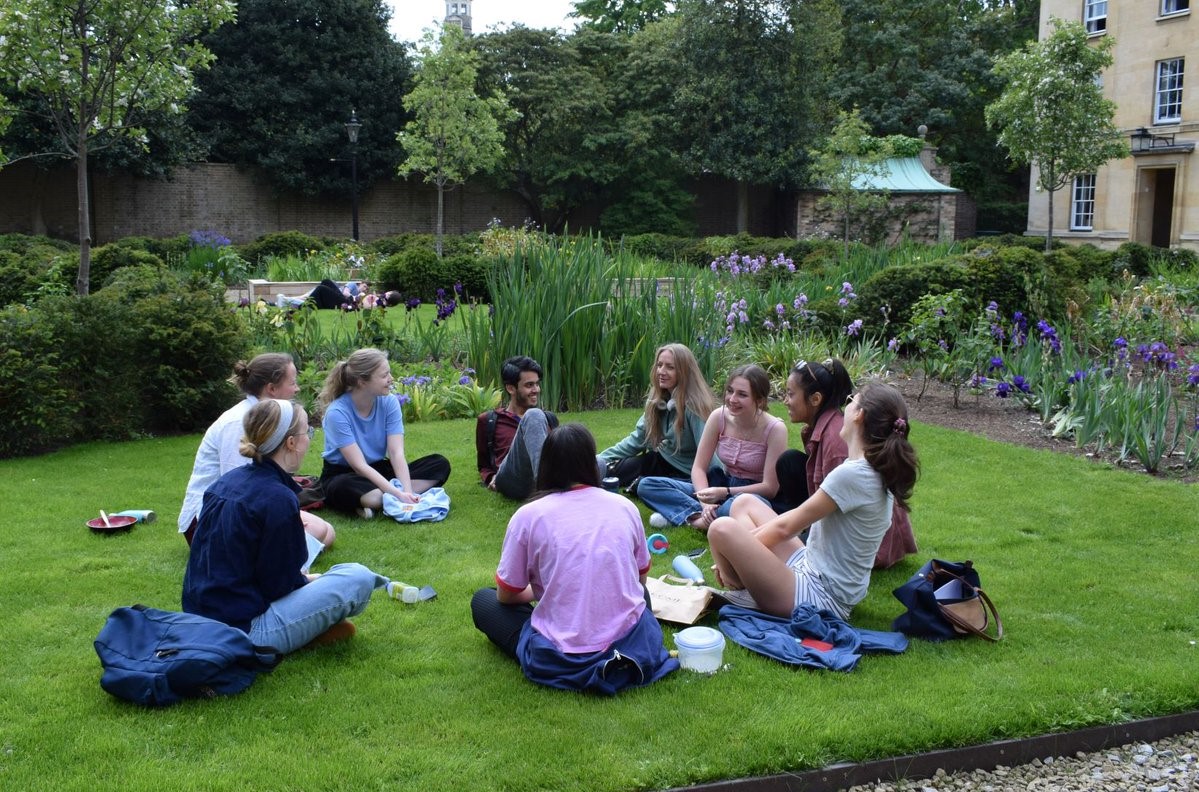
left=249, top=563, right=388, bottom=654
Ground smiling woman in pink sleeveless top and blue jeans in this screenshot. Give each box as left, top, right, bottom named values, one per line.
left=637, top=363, right=787, bottom=531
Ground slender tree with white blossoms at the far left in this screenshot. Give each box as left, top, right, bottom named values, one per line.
left=0, top=0, right=234, bottom=295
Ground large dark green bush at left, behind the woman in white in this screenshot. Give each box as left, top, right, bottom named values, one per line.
left=0, top=266, right=248, bottom=457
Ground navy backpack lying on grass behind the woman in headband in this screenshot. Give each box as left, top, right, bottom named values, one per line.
left=95, top=605, right=282, bottom=707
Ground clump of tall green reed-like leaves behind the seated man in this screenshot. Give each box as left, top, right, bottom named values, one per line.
left=459, top=237, right=724, bottom=410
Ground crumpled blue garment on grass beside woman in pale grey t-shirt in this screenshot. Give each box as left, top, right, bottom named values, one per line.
left=721, top=603, right=908, bottom=671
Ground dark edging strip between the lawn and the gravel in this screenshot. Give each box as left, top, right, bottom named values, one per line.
left=674, top=709, right=1199, bottom=792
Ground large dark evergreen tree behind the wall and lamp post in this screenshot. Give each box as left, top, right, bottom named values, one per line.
left=189, top=0, right=411, bottom=197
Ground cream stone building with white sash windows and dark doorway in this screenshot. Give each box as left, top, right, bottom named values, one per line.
left=1026, top=0, right=1199, bottom=249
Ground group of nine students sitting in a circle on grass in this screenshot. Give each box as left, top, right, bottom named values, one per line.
left=180, top=344, right=918, bottom=693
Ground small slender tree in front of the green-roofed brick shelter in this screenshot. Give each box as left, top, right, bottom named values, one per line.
left=811, top=108, right=891, bottom=260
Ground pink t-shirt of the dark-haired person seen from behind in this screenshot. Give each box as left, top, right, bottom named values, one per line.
left=495, top=486, right=650, bottom=654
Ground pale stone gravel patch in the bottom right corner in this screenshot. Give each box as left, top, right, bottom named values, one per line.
left=849, top=732, right=1199, bottom=792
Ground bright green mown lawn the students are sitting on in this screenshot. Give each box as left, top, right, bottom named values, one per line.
left=0, top=407, right=1199, bottom=792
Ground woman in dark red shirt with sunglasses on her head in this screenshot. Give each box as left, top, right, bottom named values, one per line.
left=775, top=358, right=916, bottom=569
